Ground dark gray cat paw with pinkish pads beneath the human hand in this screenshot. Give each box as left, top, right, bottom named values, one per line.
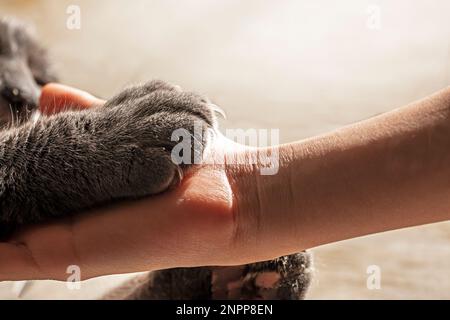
left=103, top=252, right=313, bottom=300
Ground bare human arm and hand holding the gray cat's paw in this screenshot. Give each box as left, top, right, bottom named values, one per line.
left=0, top=84, right=450, bottom=280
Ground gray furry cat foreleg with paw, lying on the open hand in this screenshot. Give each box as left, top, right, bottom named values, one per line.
left=0, top=81, right=214, bottom=231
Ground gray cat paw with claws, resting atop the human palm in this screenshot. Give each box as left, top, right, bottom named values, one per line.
left=98, top=80, right=216, bottom=196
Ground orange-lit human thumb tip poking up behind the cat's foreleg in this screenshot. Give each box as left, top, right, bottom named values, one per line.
left=39, top=83, right=105, bottom=115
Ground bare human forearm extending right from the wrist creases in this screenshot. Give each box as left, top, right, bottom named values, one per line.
left=236, top=88, right=450, bottom=253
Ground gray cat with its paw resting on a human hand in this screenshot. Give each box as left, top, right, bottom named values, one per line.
left=0, top=19, right=311, bottom=299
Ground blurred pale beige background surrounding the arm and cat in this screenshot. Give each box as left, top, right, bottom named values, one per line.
left=0, top=0, right=450, bottom=299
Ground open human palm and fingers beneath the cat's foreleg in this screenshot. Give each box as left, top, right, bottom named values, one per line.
left=0, top=160, right=237, bottom=280
